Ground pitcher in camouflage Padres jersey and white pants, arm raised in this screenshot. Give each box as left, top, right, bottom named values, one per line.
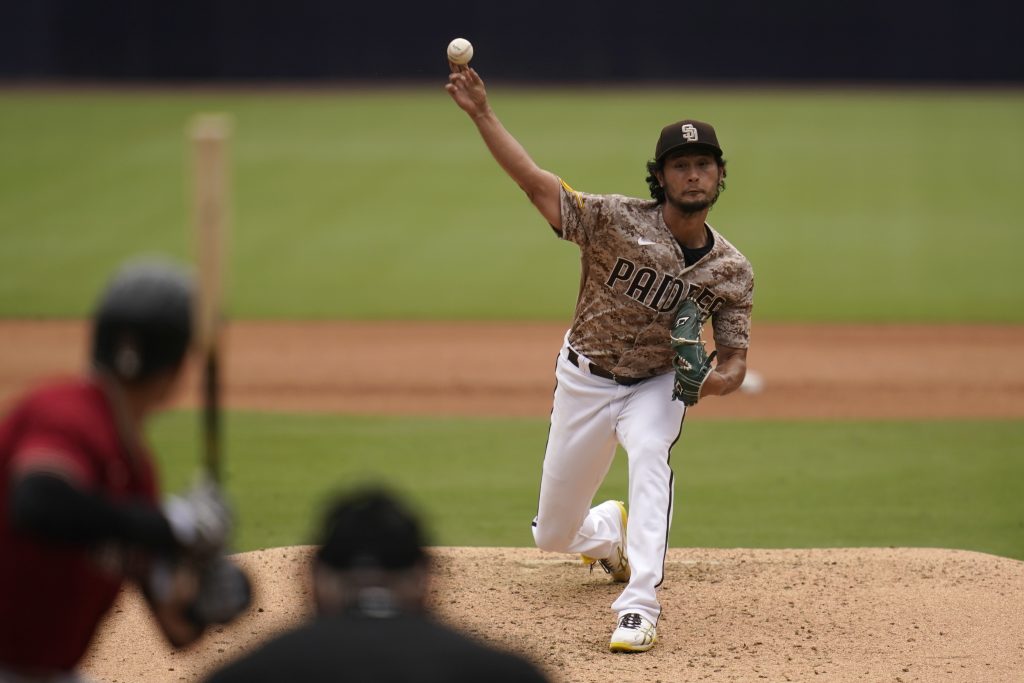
left=445, top=62, right=754, bottom=652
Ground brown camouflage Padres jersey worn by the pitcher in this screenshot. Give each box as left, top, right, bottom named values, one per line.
left=561, top=181, right=754, bottom=378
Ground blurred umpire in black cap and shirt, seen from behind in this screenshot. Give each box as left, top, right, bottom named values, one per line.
left=202, top=489, right=545, bottom=683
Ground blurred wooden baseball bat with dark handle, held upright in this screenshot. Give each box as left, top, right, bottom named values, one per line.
left=190, top=114, right=230, bottom=482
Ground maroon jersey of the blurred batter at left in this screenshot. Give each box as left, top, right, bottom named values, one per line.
left=0, top=379, right=157, bottom=673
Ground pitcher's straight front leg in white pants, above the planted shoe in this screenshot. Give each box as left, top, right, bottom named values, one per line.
left=611, top=374, right=686, bottom=625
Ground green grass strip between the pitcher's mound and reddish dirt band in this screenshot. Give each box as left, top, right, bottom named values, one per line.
left=153, top=413, right=1024, bottom=559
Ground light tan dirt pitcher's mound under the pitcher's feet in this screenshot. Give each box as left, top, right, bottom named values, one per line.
left=83, top=547, right=1024, bottom=683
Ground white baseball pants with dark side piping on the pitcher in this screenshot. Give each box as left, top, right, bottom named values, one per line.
left=534, top=333, right=686, bottom=624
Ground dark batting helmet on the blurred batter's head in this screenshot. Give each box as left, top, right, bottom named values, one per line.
left=92, top=260, right=193, bottom=382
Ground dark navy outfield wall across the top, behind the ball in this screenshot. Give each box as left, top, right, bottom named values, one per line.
left=0, top=0, right=1024, bottom=83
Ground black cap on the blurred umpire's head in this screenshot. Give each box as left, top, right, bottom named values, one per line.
left=316, top=488, right=426, bottom=571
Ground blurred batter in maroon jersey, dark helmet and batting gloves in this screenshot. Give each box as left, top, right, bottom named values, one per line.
left=0, top=261, right=250, bottom=683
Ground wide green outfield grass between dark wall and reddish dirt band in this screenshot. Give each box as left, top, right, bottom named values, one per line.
left=0, top=87, right=1024, bottom=323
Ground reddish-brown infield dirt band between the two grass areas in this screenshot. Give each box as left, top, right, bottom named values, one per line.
left=6, top=321, right=1024, bottom=420
